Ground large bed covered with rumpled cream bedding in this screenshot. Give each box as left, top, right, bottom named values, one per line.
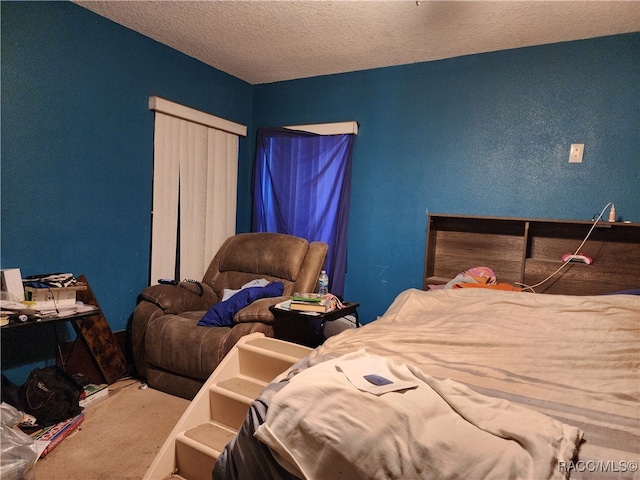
left=213, top=219, right=640, bottom=479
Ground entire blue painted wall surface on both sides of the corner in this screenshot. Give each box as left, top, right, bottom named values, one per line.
left=0, top=2, right=640, bottom=381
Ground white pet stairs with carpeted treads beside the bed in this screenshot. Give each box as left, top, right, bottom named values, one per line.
left=144, top=333, right=311, bottom=480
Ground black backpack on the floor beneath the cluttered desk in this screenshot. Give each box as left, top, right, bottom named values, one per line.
left=14, top=366, right=83, bottom=427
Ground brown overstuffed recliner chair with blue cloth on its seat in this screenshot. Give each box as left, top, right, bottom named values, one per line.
left=131, top=233, right=328, bottom=399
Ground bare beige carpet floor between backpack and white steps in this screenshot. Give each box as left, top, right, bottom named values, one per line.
left=35, top=380, right=190, bottom=480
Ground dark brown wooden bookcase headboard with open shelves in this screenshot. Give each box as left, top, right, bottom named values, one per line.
left=423, top=214, right=640, bottom=295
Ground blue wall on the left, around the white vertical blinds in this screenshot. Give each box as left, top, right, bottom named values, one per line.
left=0, top=2, right=253, bottom=380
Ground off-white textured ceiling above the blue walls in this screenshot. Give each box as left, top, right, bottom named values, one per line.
left=74, top=0, right=640, bottom=84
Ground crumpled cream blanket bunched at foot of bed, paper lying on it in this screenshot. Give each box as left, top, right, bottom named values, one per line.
left=255, top=350, right=582, bottom=480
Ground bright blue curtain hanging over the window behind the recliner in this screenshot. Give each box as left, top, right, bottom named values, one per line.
left=253, top=128, right=355, bottom=297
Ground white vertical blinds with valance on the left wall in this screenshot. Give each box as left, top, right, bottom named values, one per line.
left=149, top=97, right=246, bottom=283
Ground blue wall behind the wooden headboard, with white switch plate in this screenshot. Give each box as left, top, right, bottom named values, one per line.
left=253, top=34, right=640, bottom=322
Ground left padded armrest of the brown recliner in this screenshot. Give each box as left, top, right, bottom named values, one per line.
left=140, top=282, right=218, bottom=314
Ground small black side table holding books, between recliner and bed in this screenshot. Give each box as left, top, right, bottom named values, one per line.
left=269, top=302, right=360, bottom=348
